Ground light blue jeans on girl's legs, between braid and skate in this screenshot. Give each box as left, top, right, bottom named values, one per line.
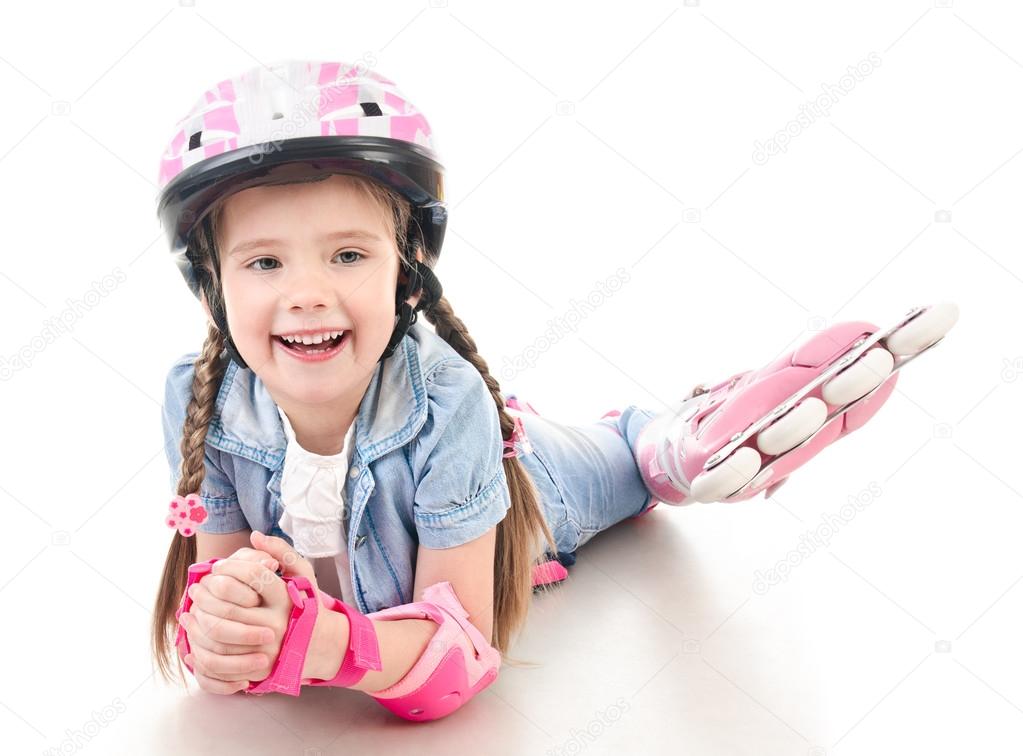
left=503, top=405, right=655, bottom=565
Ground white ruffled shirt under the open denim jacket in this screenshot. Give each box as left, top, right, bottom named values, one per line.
left=277, top=406, right=356, bottom=606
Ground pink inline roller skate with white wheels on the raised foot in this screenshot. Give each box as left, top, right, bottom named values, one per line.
left=635, top=303, right=959, bottom=505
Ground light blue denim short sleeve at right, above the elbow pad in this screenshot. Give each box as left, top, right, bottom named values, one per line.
left=411, top=359, right=512, bottom=548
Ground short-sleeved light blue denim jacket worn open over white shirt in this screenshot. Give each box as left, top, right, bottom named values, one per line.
left=163, top=322, right=512, bottom=614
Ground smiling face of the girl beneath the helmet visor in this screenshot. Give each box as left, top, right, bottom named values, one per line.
left=217, top=174, right=417, bottom=404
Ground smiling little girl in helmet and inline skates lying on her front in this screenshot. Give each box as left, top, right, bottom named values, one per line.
left=152, top=61, right=958, bottom=720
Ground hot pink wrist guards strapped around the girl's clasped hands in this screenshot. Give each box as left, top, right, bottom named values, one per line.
left=174, top=559, right=382, bottom=696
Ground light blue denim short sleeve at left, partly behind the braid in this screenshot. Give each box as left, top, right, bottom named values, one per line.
left=163, top=352, right=249, bottom=533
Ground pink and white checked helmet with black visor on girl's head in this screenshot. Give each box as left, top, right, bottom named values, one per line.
left=158, top=60, right=447, bottom=297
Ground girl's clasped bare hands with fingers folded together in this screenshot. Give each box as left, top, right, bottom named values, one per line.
left=180, top=532, right=319, bottom=695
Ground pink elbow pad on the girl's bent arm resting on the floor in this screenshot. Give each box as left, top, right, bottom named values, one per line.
left=366, top=580, right=501, bottom=721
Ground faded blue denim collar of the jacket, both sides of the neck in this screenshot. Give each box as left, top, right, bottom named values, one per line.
left=206, top=323, right=427, bottom=470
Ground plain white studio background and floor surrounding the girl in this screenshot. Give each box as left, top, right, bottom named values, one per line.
left=0, top=0, right=1023, bottom=756
